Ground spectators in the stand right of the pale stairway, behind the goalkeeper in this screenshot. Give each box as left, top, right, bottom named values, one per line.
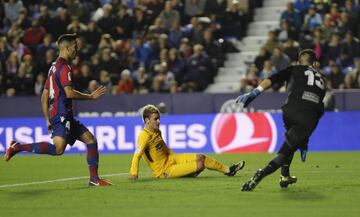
left=240, top=0, right=360, bottom=91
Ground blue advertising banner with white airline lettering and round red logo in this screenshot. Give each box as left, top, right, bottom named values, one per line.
left=0, top=112, right=360, bottom=153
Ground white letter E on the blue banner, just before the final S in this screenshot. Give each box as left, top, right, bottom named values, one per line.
left=169, top=124, right=186, bottom=149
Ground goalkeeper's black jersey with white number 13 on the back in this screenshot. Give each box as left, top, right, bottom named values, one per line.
left=269, top=65, right=325, bottom=112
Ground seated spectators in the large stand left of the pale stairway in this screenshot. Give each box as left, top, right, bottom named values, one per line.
left=0, top=0, right=262, bottom=97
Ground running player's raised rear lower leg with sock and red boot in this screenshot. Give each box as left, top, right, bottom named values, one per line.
left=5, top=141, right=57, bottom=161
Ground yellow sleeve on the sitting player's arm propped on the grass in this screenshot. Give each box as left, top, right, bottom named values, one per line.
left=130, top=131, right=149, bottom=175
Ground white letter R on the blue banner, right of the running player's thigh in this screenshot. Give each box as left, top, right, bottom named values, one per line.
left=96, top=126, right=116, bottom=150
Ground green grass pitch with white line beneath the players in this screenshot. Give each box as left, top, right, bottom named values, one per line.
left=0, top=152, right=360, bottom=217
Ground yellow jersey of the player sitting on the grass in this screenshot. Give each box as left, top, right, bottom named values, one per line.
left=130, top=128, right=174, bottom=177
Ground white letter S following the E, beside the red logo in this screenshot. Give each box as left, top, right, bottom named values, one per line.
left=187, top=124, right=207, bottom=149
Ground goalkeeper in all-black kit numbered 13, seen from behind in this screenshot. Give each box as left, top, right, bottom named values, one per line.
left=236, top=49, right=325, bottom=191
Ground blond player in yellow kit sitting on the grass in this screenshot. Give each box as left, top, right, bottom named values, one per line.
left=129, top=105, right=245, bottom=180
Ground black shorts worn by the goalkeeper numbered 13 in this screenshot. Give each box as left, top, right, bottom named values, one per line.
left=283, top=106, right=321, bottom=150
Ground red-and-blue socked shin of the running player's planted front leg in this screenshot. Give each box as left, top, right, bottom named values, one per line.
left=86, top=143, right=99, bottom=182
